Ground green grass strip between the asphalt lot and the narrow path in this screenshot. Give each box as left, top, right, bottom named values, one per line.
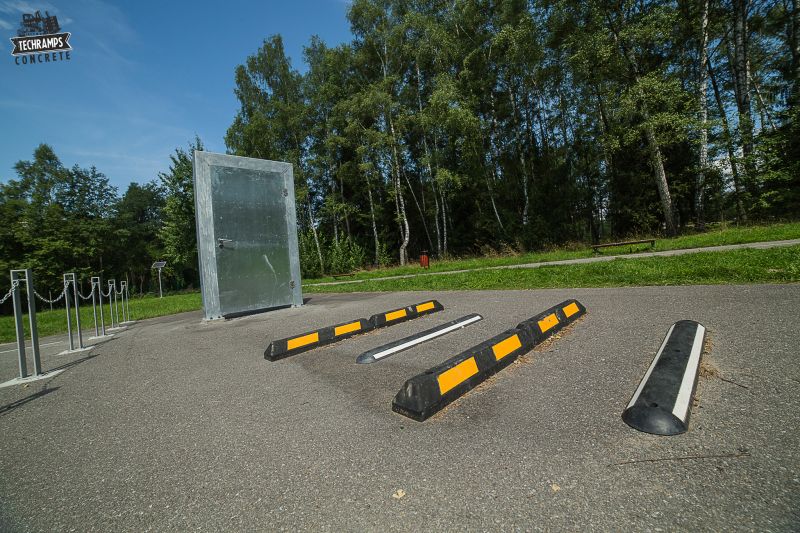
left=305, top=246, right=800, bottom=293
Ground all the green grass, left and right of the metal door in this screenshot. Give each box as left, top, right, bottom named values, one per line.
left=0, top=223, right=800, bottom=342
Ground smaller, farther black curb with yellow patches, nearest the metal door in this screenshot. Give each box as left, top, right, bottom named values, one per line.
left=264, top=300, right=444, bottom=361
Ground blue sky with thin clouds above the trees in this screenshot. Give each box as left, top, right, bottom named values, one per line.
left=0, top=0, right=351, bottom=193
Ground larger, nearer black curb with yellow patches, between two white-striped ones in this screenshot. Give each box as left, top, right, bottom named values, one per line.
left=392, top=300, right=586, bottom=421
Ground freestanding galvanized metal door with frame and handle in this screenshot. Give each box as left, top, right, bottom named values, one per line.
left=194, top=151, right=303, bottom=319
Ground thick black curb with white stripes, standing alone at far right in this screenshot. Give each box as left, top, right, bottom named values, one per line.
left=622, top=320, right=706, bottom=435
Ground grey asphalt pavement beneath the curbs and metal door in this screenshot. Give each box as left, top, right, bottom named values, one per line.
left=0, top=285, right=800, bottom=532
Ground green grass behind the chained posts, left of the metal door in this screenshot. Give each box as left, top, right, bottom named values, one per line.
left=0, top=292, right=202, bottom=342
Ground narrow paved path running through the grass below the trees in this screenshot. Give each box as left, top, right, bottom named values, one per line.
left=303, top=239, right=800, bottom=287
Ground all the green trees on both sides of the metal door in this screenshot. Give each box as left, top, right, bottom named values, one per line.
left=0, top=0, right=800, bottom=304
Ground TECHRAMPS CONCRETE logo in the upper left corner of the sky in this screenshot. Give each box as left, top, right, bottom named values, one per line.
left=11, top=11, right=72, bottom=65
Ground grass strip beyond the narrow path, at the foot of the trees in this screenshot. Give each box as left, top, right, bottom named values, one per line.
left=303, top=222, right=800, bottom=286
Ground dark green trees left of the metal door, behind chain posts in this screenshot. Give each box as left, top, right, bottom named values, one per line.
left=0, top=139, right=202, bottom=302
